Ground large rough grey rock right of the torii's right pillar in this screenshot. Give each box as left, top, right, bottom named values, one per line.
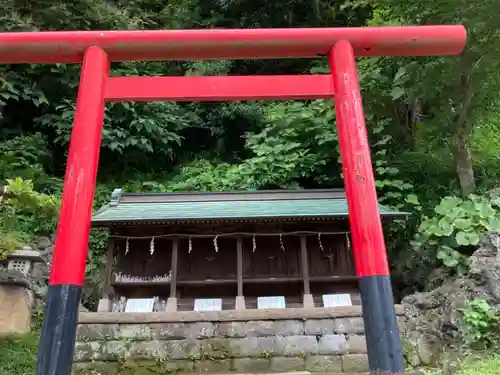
left=402, top=233, right=500, bottom=365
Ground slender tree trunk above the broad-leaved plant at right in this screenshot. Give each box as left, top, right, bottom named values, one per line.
left=451, top=132, right=476, bottom=196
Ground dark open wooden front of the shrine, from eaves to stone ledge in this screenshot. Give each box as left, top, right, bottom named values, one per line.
left=110, top=220, right=358, bottom=311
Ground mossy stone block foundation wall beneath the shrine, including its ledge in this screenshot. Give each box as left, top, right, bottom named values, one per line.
left=74, top=306, right=403, bottom=375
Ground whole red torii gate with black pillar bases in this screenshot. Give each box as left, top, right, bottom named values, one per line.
left=0, top=25, right=466, bottom=375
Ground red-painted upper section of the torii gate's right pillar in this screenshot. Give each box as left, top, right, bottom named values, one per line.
left=329, top=40, right=389, bottom=277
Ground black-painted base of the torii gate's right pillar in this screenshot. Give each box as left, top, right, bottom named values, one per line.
left=359, top=276, right=404, bottom=374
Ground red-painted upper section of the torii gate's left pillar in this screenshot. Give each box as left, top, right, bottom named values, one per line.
left=49, top=47, right=109, bottom=285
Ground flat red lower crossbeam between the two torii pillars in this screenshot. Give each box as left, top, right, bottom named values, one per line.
left=105, top=74, right=333, bottom=102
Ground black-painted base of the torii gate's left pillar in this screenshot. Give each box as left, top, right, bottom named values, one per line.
left=36, top=285, right=83, bottom=375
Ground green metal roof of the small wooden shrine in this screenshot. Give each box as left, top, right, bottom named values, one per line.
left=92, top=190, right=408, bottom=226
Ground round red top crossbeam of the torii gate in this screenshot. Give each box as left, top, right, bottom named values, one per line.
left=0, top=25, right=466, bottom=64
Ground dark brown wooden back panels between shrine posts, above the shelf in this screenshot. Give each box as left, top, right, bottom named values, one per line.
left=114, top=234, right=354, bottom=281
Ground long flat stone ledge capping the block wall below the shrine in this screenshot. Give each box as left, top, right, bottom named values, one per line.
left=78, top=305, right=404, bottom=324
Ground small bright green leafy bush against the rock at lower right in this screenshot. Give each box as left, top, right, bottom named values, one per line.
left=460, top=299, right=500, bottom=349
